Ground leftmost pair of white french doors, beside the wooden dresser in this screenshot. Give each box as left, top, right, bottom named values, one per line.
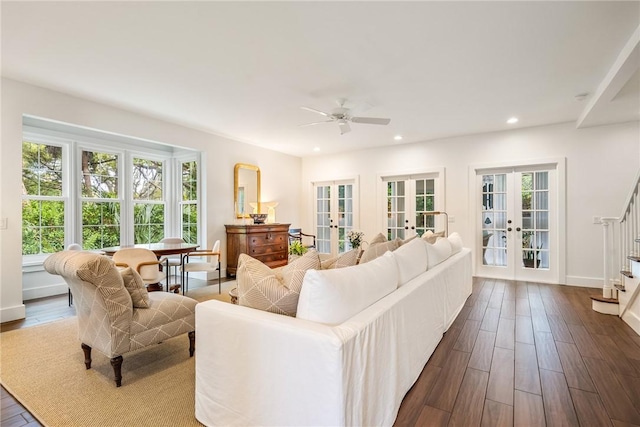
left=314, top=180, right=358, bottom=256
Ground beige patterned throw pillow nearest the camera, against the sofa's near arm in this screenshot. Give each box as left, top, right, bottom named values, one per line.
left=236, top=250, right=320, bottom=316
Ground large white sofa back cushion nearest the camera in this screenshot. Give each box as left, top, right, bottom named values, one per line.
left=296, top=253, right=398, bottom=325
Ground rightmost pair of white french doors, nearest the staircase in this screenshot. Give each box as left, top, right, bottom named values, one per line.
left=475, top=165, right=559, bottom=283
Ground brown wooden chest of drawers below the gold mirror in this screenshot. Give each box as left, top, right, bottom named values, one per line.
left=225, top=224, right=291, bottom=277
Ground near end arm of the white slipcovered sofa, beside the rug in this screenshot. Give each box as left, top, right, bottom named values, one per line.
left=195, top=300, right=345, bottom=426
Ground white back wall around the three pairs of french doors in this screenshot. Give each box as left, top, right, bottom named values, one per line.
left=301, top=122, right=640, bottom=286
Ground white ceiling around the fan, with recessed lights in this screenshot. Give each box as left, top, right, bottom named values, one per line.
left=1, top=1, right=640, bottom=157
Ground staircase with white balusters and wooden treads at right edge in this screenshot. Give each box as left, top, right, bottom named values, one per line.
left=592, top=171, right=640, bottom=334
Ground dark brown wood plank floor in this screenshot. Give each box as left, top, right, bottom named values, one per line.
left=5, top=279, right=640, bottom=427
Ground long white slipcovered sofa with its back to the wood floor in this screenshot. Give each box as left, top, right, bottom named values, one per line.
left=195, top=239, right=472, bottom=426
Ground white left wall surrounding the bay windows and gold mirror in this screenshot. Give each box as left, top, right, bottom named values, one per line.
left=0, top=79, right=301, bottom=322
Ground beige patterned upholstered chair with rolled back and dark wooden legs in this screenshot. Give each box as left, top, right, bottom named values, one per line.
left=44, top=251, right=197, bottom=387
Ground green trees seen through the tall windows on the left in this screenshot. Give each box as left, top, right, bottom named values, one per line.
left=22, top=141, right=198, bottom=255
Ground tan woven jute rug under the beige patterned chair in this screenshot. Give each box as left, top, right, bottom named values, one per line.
left=0, top=282, right=235, bottom=427
